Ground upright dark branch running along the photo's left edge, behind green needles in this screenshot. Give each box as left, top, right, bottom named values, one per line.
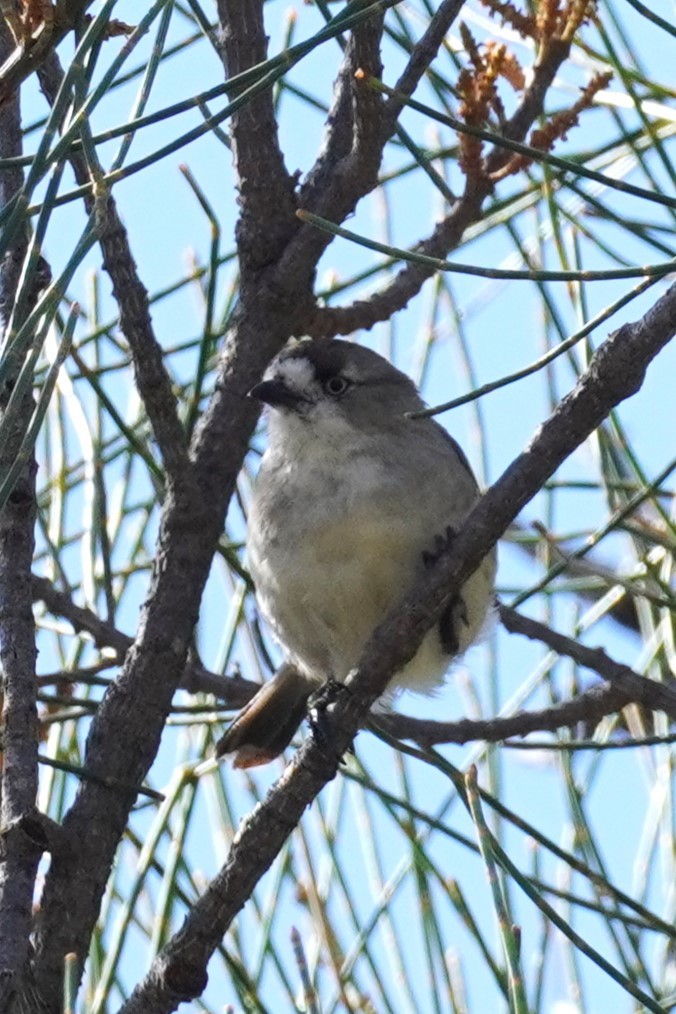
left=0, top=20, right=45, bottom=1011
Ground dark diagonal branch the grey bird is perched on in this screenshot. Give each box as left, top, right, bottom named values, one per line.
left=116, top=265, right=676, bottom=1014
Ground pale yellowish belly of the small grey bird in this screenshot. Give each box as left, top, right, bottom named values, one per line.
left=249, top=511, right=493, bottom=691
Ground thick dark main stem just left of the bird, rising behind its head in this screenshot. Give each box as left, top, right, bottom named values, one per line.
left=29, top=37, right=324, bottom=1014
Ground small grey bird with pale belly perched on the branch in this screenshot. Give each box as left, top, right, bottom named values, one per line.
left=216, top=341, right=496, bottom=768
